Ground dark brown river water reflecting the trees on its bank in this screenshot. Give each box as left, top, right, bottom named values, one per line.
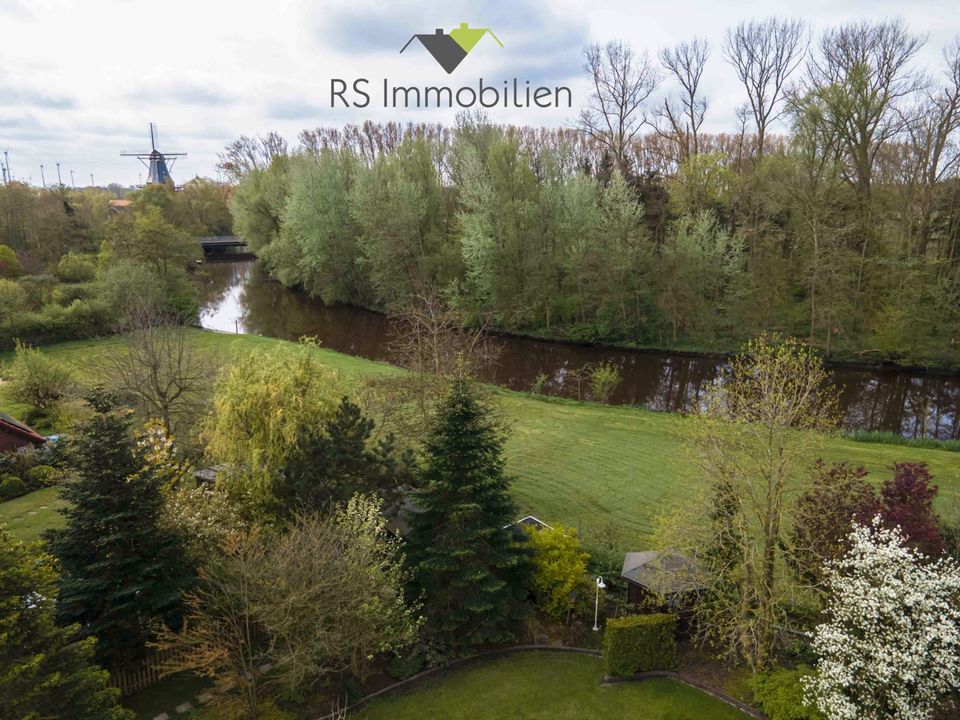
left=201, top=261, right=960, bottom=439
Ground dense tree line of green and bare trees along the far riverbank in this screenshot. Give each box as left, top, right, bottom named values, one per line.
left=231, top=18, right=960, bottom=366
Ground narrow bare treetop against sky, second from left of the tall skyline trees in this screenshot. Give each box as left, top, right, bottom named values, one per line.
left=660, top=38, right=710, bottom=162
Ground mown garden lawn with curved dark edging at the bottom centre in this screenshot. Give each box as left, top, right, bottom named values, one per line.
left=351, top=652, right=749, bottom=720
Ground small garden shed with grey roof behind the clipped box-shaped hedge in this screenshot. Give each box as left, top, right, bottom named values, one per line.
left=620, top=550, right=706, bottom=605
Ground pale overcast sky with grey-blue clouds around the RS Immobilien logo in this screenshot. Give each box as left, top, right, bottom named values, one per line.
left=0, top=0, right=960, bottom=187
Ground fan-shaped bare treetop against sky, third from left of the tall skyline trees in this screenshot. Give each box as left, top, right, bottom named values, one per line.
left=723, top=18, right=808, bottom=158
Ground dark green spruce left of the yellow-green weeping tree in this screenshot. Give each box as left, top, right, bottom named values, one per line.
left=48, top=397, right=193, bottom=666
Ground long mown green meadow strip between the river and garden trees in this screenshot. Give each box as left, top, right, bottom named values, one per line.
left=0, top=330, right=960, bottom=548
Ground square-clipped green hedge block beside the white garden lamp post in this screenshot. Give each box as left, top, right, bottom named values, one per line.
left=603, top=613, right=677, bottom=676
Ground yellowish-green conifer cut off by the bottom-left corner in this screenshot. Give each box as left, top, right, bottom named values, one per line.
left=0, top=527, right=133, bottom=720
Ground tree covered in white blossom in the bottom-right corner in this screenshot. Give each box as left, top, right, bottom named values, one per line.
left=805, top=517, right=960, bottom=720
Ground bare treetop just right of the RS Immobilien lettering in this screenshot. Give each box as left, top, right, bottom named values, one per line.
left=580, top=42, right=660, bottom=175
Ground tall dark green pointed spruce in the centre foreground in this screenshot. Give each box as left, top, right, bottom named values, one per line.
left=407, top=380, right=531, bottom=653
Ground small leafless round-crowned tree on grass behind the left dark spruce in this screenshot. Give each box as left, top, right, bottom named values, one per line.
left=108, top=308, right=212, bottom=434
